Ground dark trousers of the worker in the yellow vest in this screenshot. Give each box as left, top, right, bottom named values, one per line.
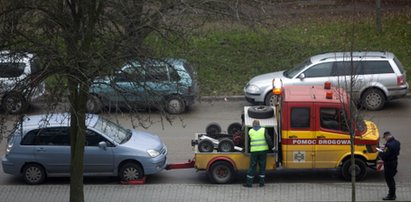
left=247, top=151, right=267, bottom=184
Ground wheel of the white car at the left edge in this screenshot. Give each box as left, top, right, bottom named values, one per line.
left=2, top=93, right=28, bottom=114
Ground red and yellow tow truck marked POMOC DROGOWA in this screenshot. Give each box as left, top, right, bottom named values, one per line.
left=193, top=83, right=379, bottom=183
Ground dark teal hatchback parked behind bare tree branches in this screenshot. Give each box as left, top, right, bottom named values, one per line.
left=87, top=59, right=198, bottom=114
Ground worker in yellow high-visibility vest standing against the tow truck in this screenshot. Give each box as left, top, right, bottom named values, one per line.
left=243, top=120, right=269, bottom=187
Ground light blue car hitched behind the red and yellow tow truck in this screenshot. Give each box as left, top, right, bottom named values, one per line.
left=2, top=113, right=167, bottom=184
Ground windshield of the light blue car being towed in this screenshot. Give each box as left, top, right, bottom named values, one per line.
left=94, top=117, right=131, bottom=144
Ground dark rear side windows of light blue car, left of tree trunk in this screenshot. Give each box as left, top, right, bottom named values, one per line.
left=21, top=127, right=70, bottom=145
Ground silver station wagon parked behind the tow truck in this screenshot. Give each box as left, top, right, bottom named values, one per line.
left=244, top=52, right=409, bottom=110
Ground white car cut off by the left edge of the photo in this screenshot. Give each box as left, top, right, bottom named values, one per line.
left=0, top=51, right=45, bottom=114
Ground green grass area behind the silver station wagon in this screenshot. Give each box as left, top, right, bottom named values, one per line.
left=147, top=14, right=411, bottom=95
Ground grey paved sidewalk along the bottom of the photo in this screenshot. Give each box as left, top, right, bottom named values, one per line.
left=0, top=183, right=411, bottom=202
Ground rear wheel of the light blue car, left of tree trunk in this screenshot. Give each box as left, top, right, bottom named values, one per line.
left=22, top=163, right=46, bottom=185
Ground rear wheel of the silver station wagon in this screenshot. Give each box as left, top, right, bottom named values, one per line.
left=361, top=88, right=386, bottom=111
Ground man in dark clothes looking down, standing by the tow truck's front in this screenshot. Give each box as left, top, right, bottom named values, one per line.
left=378, top=131, right=400, bottom=200
